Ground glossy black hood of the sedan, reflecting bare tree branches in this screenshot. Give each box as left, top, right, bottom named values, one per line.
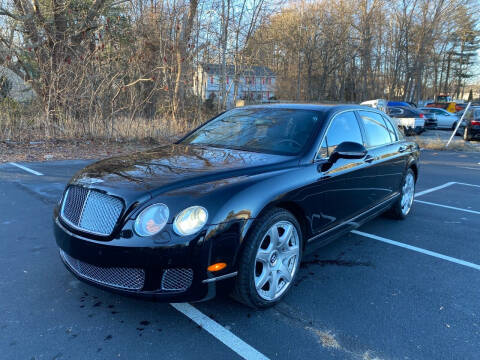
left=70, top=144, right=293, bottom=199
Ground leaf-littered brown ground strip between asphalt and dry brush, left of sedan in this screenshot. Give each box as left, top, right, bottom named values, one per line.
left=0, top=139, right=174, bottom=163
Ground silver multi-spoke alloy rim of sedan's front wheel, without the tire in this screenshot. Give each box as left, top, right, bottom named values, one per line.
left=254, top=221, right=300, bottom=301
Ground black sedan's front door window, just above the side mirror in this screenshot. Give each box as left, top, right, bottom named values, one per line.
left=317, top=111, right=363, bottom=158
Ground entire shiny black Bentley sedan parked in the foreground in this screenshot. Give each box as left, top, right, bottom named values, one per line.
left=54, top=104, right=419, bottom=307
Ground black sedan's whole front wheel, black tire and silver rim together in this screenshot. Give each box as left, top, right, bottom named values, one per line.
left=232, top=208, right=303, bottom=308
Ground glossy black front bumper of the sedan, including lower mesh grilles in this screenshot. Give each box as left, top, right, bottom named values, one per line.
left=54, top=217, right=245, bottom=302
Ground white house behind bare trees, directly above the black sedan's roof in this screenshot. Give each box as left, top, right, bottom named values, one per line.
left=193, top=64, right=276, bottom=104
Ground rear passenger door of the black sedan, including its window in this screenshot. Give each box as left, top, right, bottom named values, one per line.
left=358, top=110, right=408, bottom=203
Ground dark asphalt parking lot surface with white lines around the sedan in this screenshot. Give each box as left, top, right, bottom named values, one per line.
left=0, top=151, right=480, bottom=360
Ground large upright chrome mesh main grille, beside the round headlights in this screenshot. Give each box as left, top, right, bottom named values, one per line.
left=61, top=186, right=123, bottom=235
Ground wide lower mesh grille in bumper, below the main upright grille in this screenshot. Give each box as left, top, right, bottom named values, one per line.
left=60, top=250, right=145, bottom=290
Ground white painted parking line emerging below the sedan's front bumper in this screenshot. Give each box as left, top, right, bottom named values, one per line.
left=170, top=303, right=268, bottom=360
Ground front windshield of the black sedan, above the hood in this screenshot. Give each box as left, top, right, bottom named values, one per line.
left=182, top=108, right=320, bottom=155
